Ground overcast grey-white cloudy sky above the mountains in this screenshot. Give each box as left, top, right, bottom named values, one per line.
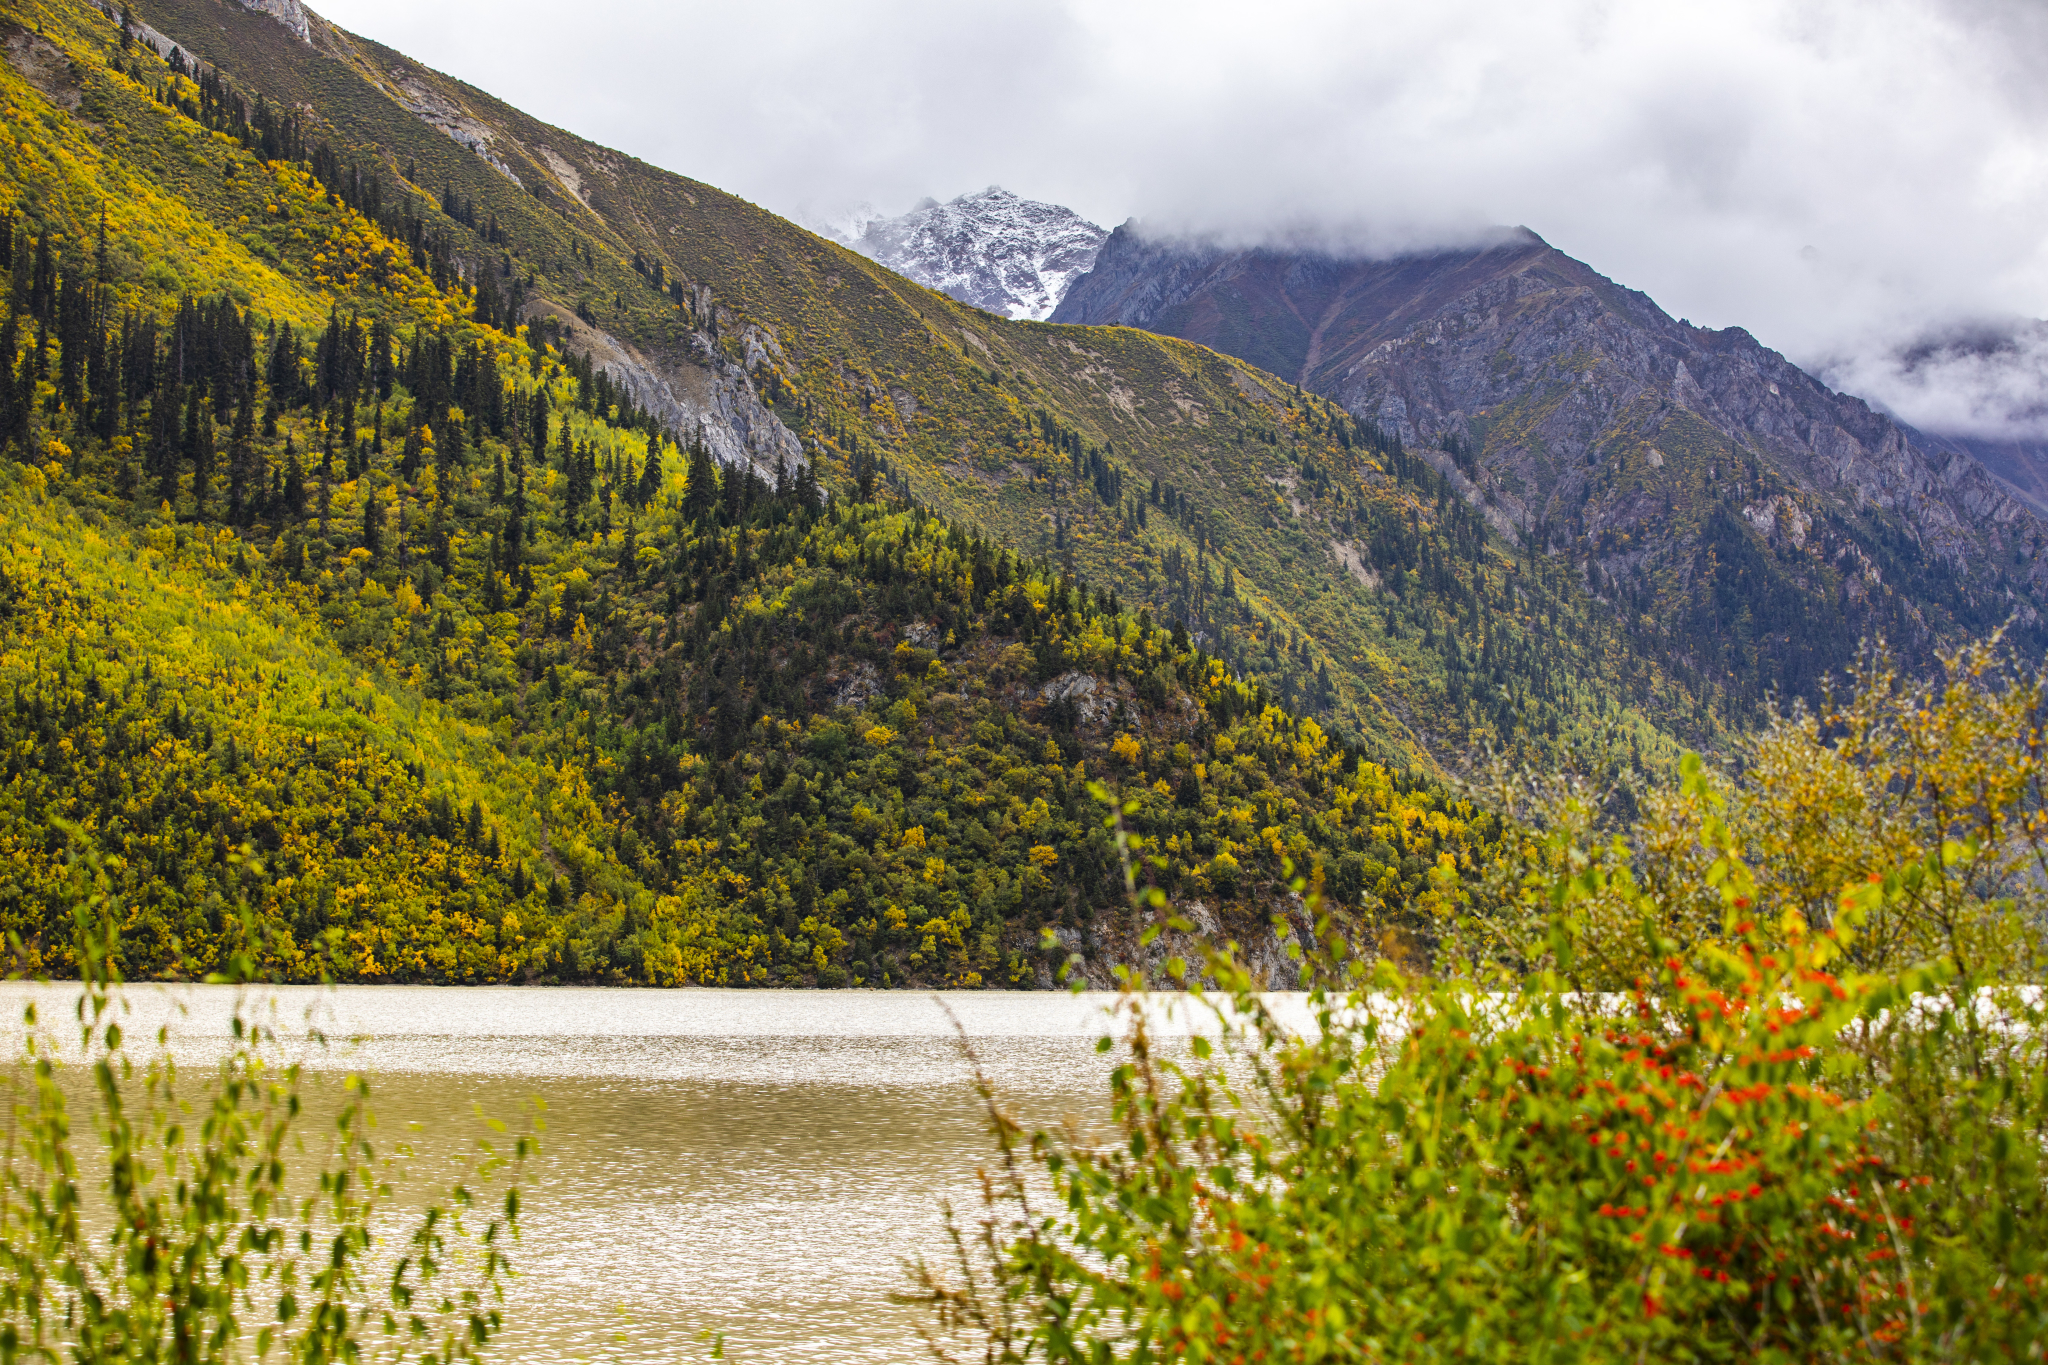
left=313, top=0, right=2048, bottom=434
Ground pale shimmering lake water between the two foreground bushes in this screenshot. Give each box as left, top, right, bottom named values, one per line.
left=0, top=986, right=1245, bottom=1361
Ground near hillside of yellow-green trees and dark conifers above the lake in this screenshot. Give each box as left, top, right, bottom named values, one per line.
left=0, top=6, right=1507, bottom=984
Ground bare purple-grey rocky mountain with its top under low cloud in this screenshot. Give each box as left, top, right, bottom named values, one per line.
left=1053, top=225, right=2048, bottom=698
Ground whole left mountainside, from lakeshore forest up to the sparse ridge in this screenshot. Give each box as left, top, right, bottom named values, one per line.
left=0, top=0, right=1679, bottom=984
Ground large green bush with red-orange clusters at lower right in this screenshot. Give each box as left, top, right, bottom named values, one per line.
left=920, top=649, right=2048, bottom=1363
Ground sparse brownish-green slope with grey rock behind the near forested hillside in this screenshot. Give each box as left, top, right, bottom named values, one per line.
left=108, top=0, right=1722, bottom=769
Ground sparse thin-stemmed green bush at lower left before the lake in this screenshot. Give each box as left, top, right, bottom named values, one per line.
left=0, top=847, right=535, bottom=1365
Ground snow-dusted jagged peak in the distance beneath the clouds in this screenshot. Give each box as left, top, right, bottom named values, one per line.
left=840, top=184, right=1110, bottom=319
